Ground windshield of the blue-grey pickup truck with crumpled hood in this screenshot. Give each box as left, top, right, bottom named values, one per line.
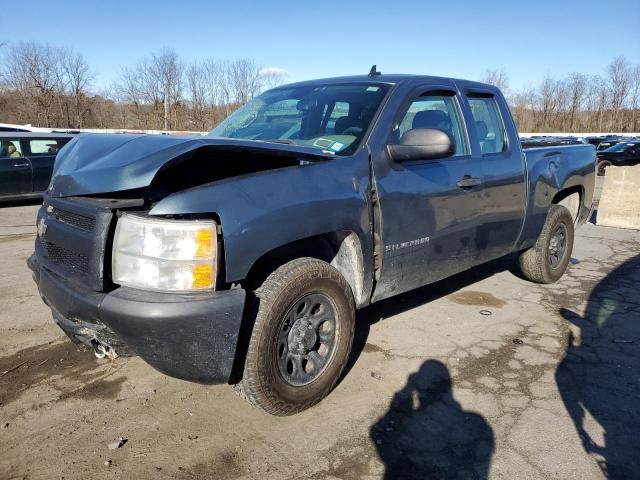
left=209, top=84, right=387, bottom=155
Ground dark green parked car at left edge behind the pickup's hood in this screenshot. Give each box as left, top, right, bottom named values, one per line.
left=0, top=132, right=73, bottom=202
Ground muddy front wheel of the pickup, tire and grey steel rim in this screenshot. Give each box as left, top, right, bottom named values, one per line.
left=236, top=258, right=355, bottom=416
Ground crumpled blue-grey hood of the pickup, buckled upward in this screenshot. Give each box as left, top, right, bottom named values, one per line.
left=49, top=134, right=331, bottom=197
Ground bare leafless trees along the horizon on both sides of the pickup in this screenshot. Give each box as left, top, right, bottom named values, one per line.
left=0, top=42, right=640, bottom=133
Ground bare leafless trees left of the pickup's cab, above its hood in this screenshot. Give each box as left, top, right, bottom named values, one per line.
left=0, top=42, right=287, bottom=131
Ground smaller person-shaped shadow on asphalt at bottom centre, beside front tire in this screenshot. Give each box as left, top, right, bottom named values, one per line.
left=370, top=360, right=494, bottom=479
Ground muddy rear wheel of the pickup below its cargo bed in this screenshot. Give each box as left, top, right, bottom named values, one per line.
left=520, top=205, right=574, bottom=283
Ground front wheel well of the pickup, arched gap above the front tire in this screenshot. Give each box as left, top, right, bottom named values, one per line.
left=242, top=231, right=366, bottom=306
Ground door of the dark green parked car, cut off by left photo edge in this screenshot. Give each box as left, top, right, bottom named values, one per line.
left=0, top=138, right=31, bottom=197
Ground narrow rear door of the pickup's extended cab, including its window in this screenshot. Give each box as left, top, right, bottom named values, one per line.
left=465, top=89, right=526, bottom=263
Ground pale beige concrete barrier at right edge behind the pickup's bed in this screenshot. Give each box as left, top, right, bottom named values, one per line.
left=596, top=165, right=640, bottom=230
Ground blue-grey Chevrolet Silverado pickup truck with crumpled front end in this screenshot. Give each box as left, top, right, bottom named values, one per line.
left=29, top=74, right=595, bottom=415
